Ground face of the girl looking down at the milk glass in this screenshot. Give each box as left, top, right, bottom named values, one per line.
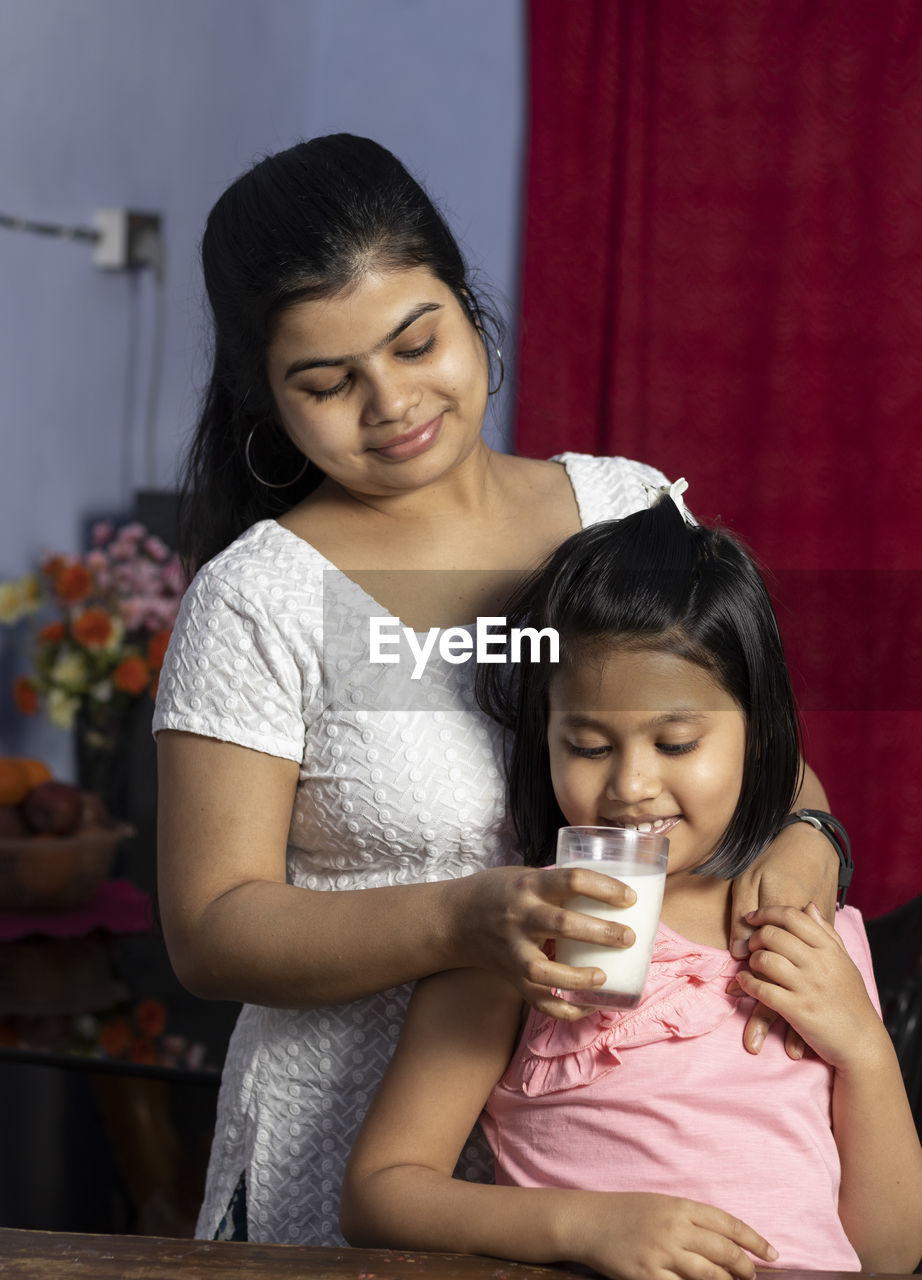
left=548, top=649, right=747, bottom=877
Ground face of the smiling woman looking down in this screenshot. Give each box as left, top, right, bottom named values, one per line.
left=266, top=268, right=488, bottom=495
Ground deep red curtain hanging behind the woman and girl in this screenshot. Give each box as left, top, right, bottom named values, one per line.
left=516, top=0, right=922, bottom=915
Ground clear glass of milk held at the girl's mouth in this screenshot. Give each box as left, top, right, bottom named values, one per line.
left=556, top=827, right=668, bottom=1009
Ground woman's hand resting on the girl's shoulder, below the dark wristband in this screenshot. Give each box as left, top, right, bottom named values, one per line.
left=730, top=822, right=839, bottom=1059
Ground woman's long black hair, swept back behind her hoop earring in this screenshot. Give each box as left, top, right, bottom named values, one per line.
left=179, top=133, right=501, bottom=568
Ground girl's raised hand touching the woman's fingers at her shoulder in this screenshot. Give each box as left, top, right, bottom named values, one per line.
left=736, top=902, right=886, bottom=1070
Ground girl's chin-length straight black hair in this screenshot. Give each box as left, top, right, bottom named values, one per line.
left=478, top=498, right=802, bottom=879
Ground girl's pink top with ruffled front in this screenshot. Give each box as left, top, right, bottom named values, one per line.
left=481, top=908, right=880, bottom=1271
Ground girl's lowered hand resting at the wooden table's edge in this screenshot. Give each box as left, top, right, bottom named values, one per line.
left=567, top=1192, right=777, bottom=1280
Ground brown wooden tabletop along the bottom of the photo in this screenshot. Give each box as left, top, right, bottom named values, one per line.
left=0, top=1229, right=910, bottom=1280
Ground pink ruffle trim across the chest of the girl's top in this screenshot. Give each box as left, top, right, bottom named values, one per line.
left=499, top=924, right=748, bottom=1097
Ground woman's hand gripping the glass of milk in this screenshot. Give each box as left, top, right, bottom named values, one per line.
left=461, top=867, right=636, bottom=1021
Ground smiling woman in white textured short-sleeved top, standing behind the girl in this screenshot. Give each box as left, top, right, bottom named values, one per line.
left=155, top=134, right=836, bottom=1244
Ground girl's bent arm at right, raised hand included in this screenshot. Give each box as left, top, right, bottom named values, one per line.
left=738, top=902, right=922, bottom=1272
